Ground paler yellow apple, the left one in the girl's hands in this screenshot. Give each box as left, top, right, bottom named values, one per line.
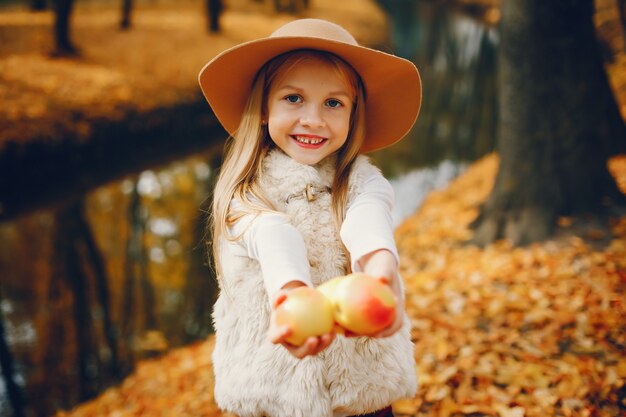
left=274, top=287, right=335, bottom=346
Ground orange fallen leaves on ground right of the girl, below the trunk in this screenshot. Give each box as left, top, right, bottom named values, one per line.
left=395, top=155, right=626, bottom=417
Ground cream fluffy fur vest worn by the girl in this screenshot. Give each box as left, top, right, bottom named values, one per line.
left=213, top=150, right=417, bottom=417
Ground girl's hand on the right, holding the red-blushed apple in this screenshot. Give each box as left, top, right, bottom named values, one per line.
left=359, top=249, right=404, bottom=337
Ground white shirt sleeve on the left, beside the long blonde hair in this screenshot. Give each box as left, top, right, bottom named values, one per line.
left=229, top=203, right=313, bottom=299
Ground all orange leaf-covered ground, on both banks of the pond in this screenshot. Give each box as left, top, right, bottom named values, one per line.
left=0, top=0, right=626, bottom=417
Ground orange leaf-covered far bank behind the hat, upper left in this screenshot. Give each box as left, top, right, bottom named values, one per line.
left=0, top=0, right=389, bottom=145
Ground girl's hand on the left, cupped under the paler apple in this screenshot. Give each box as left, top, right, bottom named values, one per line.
left=268, top=282, right=335, bottom=359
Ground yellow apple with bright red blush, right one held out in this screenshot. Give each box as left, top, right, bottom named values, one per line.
left=317, top=273, right=397, bottom=336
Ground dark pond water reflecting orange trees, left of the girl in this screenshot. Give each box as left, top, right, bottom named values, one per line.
left=0, top=155, right=215, bottom=416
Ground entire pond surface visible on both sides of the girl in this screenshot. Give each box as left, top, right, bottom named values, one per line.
left=0, top=4, right=497, bottom=416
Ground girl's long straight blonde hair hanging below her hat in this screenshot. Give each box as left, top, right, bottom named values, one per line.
left=209, top=50, right=365, bottom=276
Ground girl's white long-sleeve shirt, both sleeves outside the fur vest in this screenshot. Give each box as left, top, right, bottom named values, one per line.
left=226, top=174, right=399, bottom=299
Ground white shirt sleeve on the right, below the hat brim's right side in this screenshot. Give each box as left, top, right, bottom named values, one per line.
left=340, top=173, right=400, bottom=272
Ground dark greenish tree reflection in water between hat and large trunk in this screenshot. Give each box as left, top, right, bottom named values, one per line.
left=373, top=0, right=498, bottom=176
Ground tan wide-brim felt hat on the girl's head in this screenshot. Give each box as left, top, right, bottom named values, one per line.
left=198, top=19, right=422, bottom=152
